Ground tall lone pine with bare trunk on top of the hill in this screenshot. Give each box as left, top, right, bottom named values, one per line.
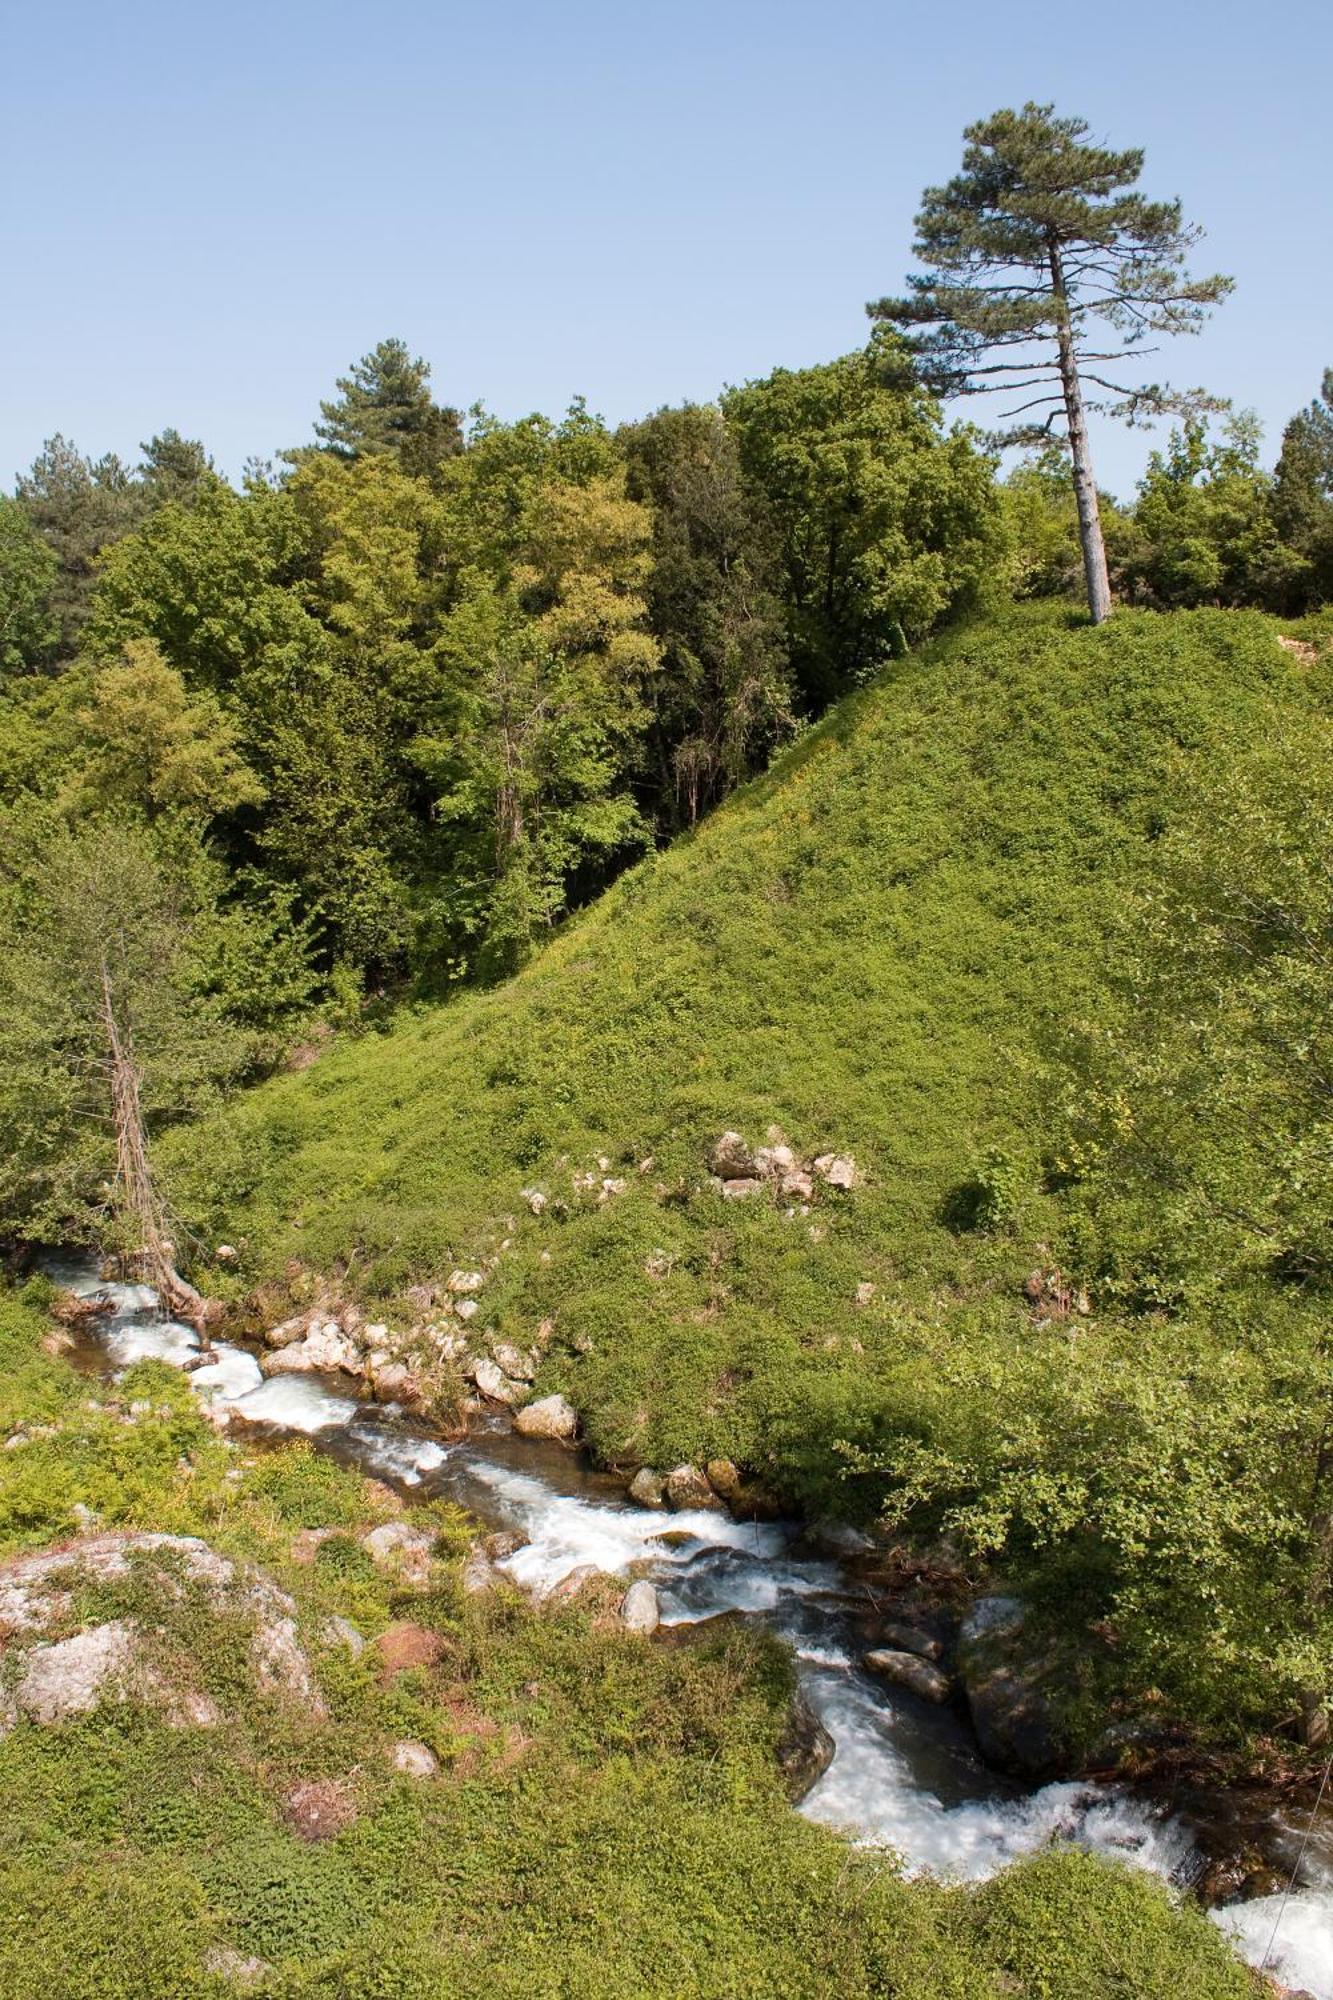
left=869, top=104, right=1231, bottom=624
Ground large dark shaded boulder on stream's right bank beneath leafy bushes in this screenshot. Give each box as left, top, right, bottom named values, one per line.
left=957, top=1596, right=1061, bottom=1780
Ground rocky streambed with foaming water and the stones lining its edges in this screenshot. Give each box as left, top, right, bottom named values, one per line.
left=28, top=1264, right=1333, bottom=2000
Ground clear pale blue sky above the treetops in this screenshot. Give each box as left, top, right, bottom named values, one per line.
left=0, top=0, right=1333, bottom=492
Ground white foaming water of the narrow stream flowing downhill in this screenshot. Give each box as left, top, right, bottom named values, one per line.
left=48, top=1262, right=1333, bottom=2000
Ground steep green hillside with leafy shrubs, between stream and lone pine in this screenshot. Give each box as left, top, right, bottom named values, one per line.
left=172, top=612, right=1333, bottom=1734
